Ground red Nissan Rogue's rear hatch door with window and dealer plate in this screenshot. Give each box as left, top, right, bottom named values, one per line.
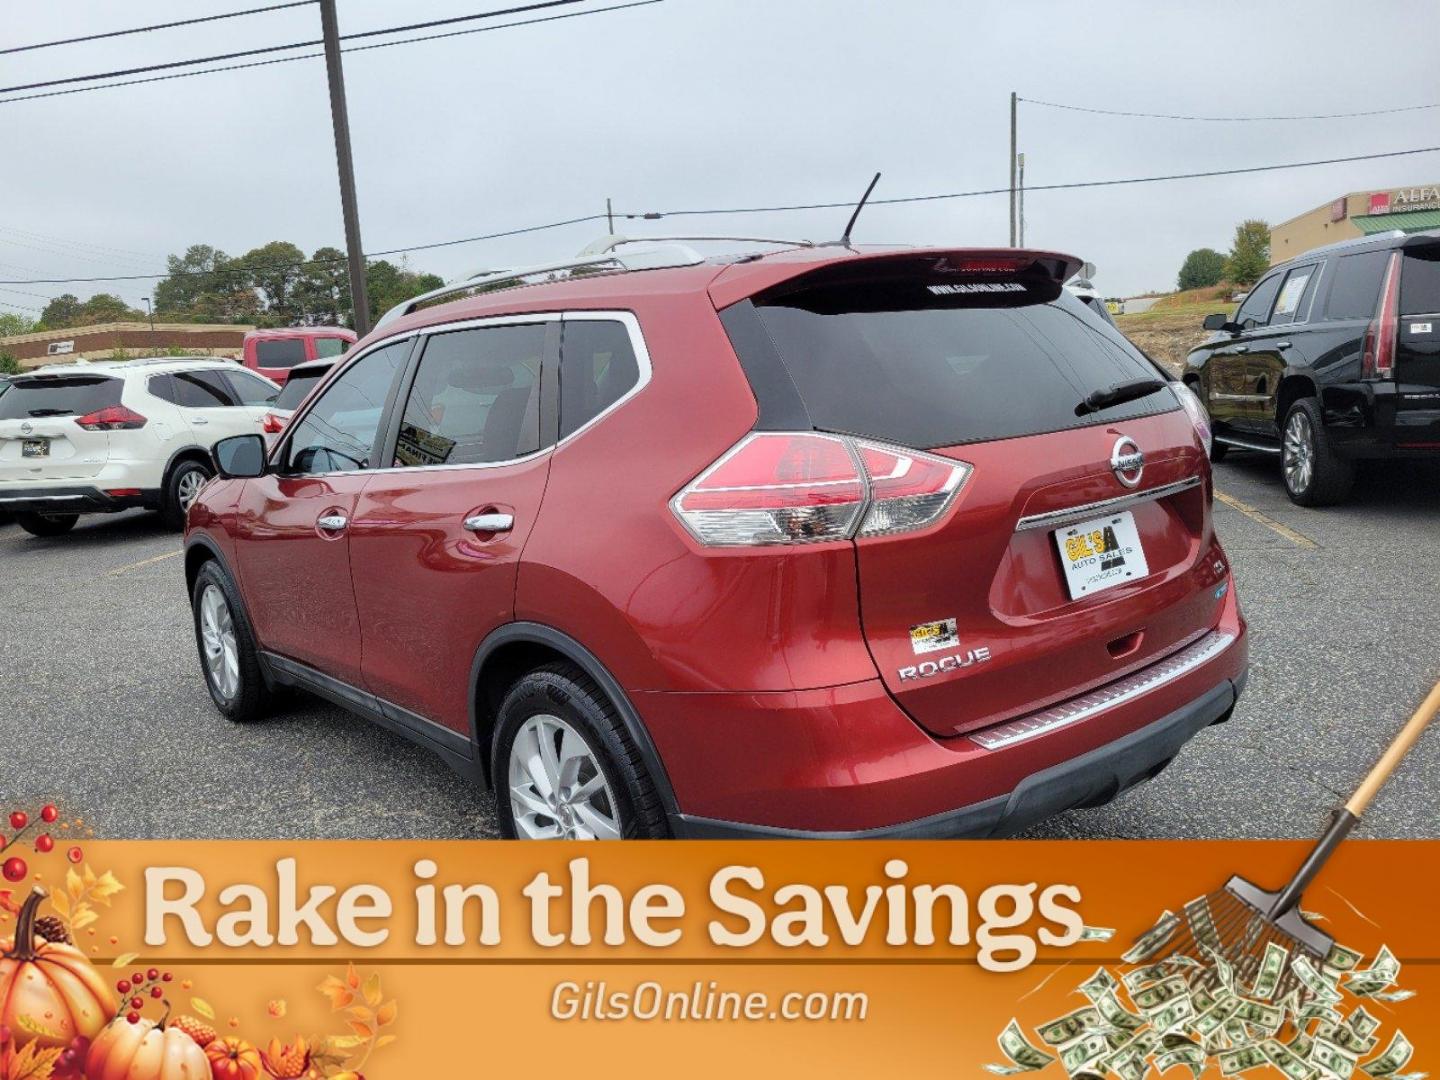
left=755, top=259, right=1223, bottom=734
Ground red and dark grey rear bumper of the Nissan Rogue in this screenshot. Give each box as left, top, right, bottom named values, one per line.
left=645, top=589, right=1248, bottom=838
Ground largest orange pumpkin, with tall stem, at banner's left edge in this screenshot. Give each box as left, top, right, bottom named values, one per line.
left=0, top=887, right=115, bottom=1048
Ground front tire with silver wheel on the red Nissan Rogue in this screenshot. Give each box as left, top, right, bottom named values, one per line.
left=190, top=560, right=271, bottom=723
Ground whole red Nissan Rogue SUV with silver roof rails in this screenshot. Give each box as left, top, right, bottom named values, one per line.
left=184, top=238, right=1247, bottom=838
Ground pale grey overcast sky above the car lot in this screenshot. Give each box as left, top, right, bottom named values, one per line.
left=0, top=0, right=1440, bottom=314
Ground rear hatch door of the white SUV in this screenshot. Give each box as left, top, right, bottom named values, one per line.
left=0, top=372, right=124, bottom=485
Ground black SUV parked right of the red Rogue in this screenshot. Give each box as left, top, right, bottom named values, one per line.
left=1184, top=230, right=1440, bottom=507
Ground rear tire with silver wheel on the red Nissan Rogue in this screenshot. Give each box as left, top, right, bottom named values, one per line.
left=490, top=662, right=670, bottom=840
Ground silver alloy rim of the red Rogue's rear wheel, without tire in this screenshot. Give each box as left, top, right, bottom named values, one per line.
left=508, top=714, right=621, bottom=840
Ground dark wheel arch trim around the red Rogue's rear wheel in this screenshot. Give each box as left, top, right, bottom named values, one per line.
left=469, top=622, right=680, bottom=818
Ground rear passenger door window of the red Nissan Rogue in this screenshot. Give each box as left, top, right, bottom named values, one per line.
left=395, top=323, right=546, bottom=467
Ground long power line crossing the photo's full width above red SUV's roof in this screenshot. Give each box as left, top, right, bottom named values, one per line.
left=0, top=145, right=1440, bottom=285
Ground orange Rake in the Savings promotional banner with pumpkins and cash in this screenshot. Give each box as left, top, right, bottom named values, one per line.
left=0, top=841, right=1440, bottom=1080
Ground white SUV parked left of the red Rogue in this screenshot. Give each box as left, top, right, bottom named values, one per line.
left=0, top=357, right=279, bottom=536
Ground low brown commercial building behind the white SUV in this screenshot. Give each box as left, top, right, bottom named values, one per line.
left=0, top=323, right=255, bottom=369
